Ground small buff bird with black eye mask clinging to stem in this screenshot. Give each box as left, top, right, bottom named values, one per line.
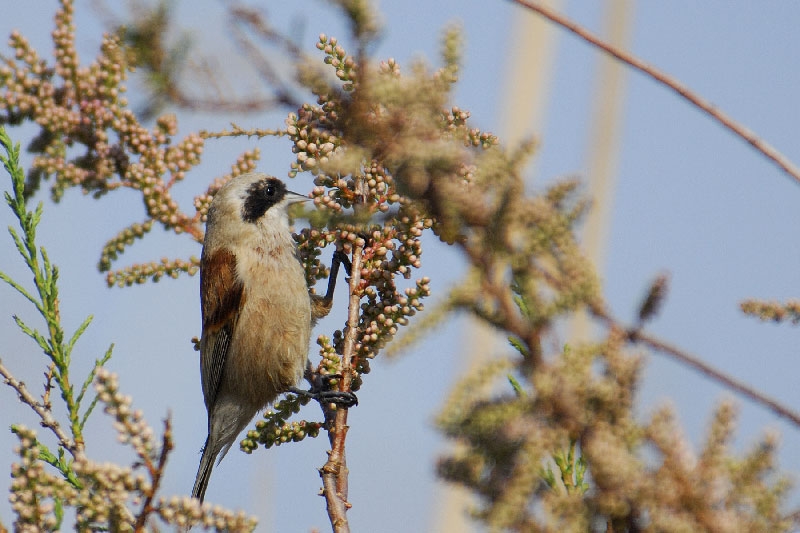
left=192, top=172, right=314, bottom=501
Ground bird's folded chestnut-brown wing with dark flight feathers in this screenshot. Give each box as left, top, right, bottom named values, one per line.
left=200, top=250, right=244, bottom=412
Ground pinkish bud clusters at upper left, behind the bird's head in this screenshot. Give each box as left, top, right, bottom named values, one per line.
left=0, top=0, right=266, bottom=285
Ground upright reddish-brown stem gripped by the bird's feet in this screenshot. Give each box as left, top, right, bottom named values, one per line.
left=320, top=239, right=364, bottom=533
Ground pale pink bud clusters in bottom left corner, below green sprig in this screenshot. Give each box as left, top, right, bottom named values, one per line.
left=7, top=369, right=256, bottom=532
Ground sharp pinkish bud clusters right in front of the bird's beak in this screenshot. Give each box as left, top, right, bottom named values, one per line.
left=286, top=35, right=454, bottom=390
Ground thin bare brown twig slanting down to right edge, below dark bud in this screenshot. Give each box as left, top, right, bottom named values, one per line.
left=591, top=304, right=800, bottom=428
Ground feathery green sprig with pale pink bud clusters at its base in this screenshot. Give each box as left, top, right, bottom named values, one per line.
left=0, top=127, right=255, bottom=531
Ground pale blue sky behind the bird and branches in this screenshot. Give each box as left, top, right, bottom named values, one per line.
left=0, top=0, right=800, bottom=533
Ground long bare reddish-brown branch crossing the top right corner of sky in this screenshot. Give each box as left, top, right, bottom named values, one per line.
left=511, top=0, right=800, bottom=187
